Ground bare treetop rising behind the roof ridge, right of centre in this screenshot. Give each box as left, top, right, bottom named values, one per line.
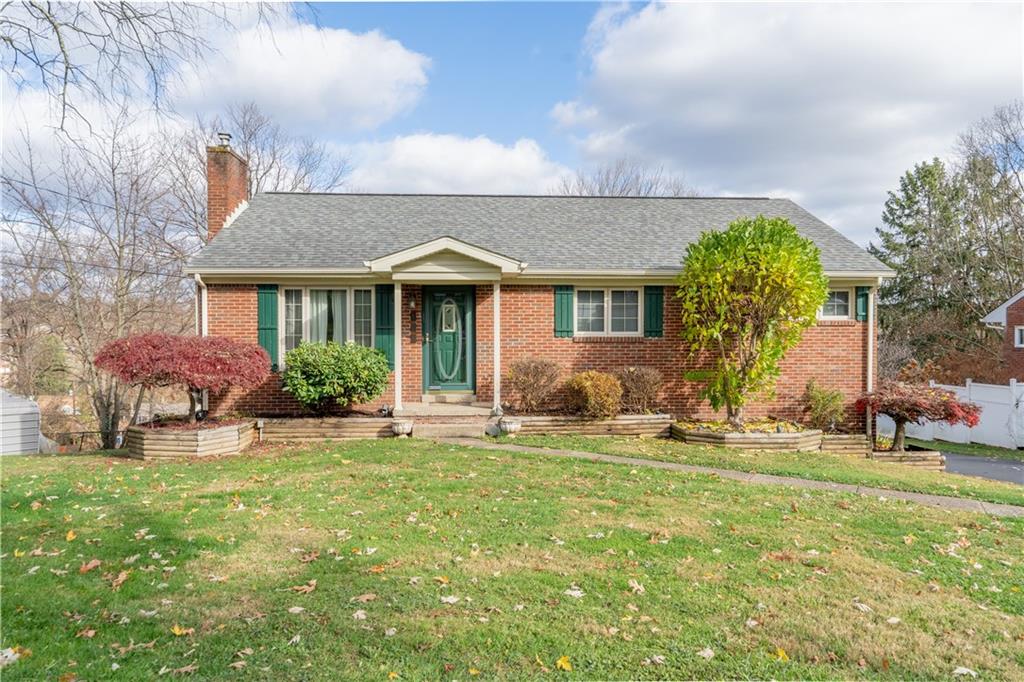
left=553, top=159, right=699, bottom=197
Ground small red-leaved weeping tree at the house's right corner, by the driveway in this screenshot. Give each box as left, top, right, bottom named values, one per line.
left=857, top=381, right=981, bottom=452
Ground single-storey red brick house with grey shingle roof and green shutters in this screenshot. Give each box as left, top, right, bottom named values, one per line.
left=187, top=137, right=891, bottom=426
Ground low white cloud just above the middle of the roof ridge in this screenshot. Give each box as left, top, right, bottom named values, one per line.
left=349, top=133, right=567, bottom=194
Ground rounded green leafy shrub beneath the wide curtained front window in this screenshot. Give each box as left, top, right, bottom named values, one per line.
left=283, top=341, right=388, bottom=415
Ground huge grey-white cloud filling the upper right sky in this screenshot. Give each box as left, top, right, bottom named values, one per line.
left=552, top=3, right=1024, bottom=242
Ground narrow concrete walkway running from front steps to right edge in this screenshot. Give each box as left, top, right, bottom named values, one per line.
left=438, top=438, right=1024, bottom=517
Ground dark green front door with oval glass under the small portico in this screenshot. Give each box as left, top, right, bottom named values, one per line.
left=423, top=287, right=476, bottom=392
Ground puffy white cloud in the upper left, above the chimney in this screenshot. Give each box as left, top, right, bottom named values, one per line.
left=175, top=18, right=430, bottom=132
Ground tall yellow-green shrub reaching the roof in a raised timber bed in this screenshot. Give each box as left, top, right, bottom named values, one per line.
left=676, top=216, right=828, bottom=427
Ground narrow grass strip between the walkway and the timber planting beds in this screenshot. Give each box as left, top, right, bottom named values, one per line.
left=515, top=436, right=1024, bottom=505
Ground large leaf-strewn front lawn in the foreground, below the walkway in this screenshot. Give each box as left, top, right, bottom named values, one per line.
left=0, top=439, right=1024, bottom=682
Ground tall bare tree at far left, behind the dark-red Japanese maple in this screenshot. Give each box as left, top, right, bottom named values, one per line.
left=3, top=117, right=193, bottom=447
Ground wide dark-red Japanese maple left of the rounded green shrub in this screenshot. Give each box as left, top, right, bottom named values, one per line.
left=93, top=333, right=270, bottom=423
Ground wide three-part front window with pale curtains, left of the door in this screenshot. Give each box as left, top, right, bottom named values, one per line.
left=281, top=287, right=374, bottom=360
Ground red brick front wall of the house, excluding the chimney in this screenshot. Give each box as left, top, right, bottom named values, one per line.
left=208, top=278, right=867, bottom=428
